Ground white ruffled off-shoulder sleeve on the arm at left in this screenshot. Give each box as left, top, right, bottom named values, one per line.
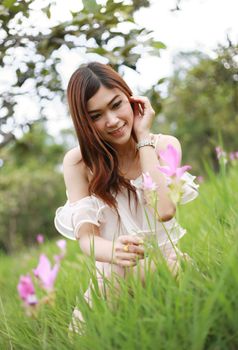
left=54, top=196, right=105, bottom=240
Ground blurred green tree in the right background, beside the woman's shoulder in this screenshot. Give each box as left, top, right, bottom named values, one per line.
left=152, top=44, right=238, bottom=171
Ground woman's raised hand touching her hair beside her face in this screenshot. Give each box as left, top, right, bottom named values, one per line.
left=130, top=96, right=155, bottom=141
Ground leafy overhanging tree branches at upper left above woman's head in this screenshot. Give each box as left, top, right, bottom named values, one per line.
left=0, top=0, right=164, bottom=146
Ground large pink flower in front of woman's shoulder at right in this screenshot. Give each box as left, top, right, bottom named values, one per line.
left=158, top=145, right=191, bottom=179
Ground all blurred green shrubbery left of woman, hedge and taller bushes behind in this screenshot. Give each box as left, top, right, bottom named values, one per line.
left=0, top=125, right=65, bottom=252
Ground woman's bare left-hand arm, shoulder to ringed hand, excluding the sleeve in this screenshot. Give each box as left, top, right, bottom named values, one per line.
left=63, top=147, right=144, bottom=266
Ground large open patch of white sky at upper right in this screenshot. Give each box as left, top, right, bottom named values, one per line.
left=127, top=0, right=238, bottom=91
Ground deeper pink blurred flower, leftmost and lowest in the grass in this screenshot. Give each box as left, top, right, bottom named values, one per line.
left=17, top=275, right=38, bottom=305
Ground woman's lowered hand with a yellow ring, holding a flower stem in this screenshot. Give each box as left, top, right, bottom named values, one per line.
left=112, top=235, right=144, bottom=267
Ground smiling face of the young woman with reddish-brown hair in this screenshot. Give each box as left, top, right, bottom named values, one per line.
left=87, top=86, right=134, bottom=146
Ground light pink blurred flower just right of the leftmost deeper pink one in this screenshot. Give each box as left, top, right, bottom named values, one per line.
left=34, top=254, right=59, bottom=291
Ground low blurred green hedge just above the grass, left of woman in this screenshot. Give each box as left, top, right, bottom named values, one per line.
left=0, top=167, right=65, bottom=252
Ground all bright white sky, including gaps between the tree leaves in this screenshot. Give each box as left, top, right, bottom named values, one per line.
left=0, top=0, right=238, bottom=139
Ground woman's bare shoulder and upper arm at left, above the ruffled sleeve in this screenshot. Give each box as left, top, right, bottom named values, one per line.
left=63, top=147, right=88, bottom=202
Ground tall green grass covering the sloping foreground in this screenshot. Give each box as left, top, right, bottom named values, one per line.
left=0, top=167, right=238, bottom=350
